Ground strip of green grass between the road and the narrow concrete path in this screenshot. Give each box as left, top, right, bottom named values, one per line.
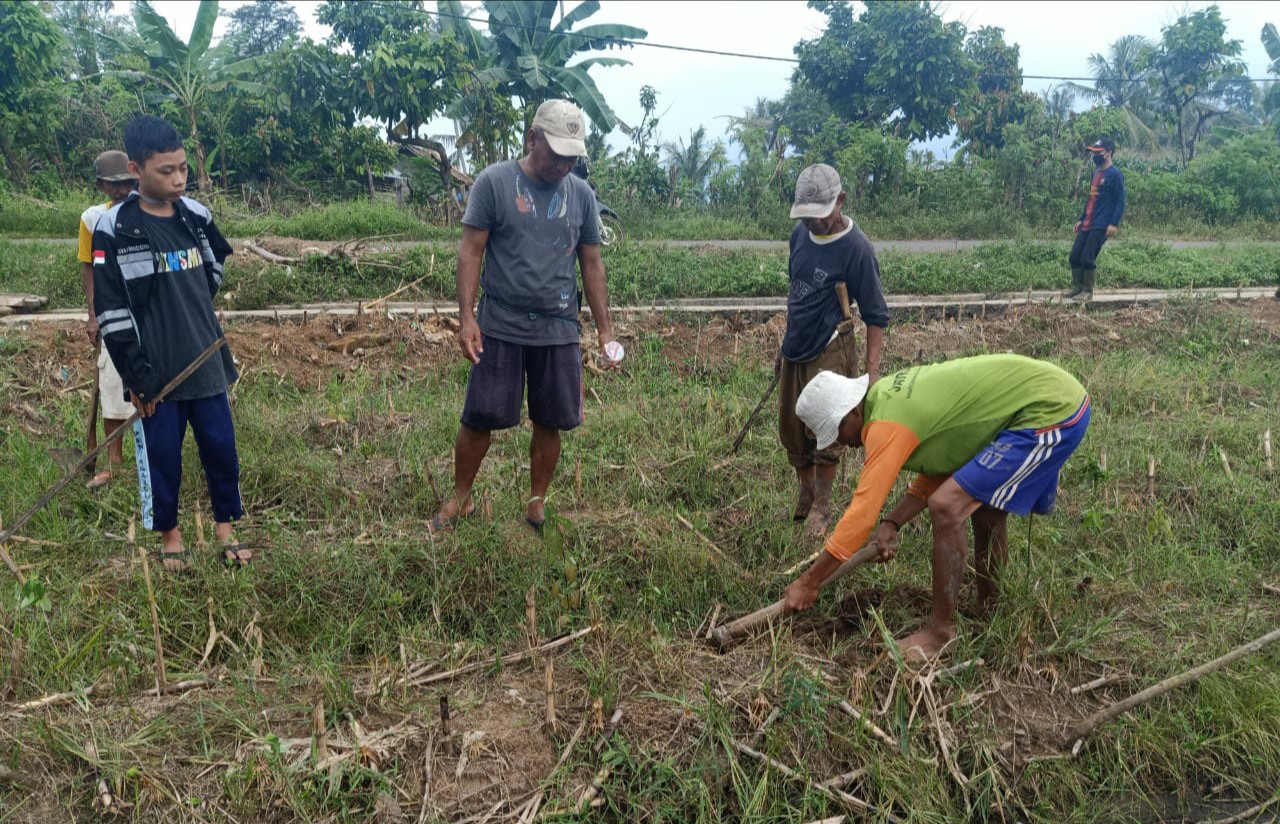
left=0, top=239, right=1280, bottom=316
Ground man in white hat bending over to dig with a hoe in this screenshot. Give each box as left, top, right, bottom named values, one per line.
left=786, top=354, right=1089, bottom=658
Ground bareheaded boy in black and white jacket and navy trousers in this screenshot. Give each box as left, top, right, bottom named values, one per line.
left=93, top=115, right=252, bottom=572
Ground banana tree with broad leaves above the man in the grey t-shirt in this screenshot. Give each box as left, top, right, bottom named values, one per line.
left=460, top=0, right=649, bottom=132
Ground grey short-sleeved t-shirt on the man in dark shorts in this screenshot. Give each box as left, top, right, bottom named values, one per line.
left=462, top=160, right=600, bottom=347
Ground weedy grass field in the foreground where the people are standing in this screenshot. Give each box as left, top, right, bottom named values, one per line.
left=0, top=302, right=1280, bottom=823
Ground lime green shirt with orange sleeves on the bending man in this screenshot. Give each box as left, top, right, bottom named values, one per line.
left=827, top=354, right=1085, bottom=560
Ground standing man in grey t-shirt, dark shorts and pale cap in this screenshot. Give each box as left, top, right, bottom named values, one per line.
left=430, top=100, right=618, bottom=534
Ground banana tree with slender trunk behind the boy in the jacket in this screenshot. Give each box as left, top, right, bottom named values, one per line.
left=121, top=0, right=266, bottom=192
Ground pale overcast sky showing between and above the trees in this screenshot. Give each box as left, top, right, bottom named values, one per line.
left=154, top=0, right=1280, bottom=156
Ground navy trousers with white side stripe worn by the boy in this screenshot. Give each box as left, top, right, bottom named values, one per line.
left=133, top=392, right=244, bottom=532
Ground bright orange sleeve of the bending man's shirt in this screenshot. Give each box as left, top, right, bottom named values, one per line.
left=827, top=421, right=920, bottom=563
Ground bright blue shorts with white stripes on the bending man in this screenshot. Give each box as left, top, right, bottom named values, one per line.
left=951, top=395, right=1091, bottom=516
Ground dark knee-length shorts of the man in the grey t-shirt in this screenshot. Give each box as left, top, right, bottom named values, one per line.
left=462, top=335, right=582, bottom=431
